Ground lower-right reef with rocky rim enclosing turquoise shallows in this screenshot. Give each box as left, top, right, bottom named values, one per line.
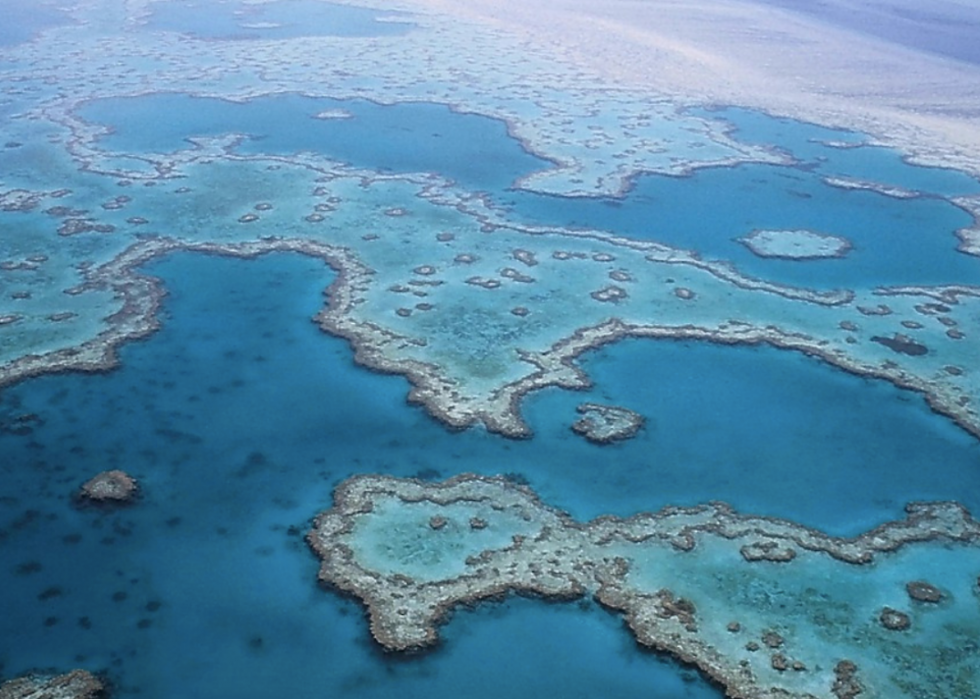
left=307, top=474, right=980, bottom=699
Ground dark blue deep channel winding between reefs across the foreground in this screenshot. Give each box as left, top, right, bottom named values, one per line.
left=0, top=254, right=980, bottom=699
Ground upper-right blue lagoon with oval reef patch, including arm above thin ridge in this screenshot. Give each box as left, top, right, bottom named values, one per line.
left=499, top=103, right=980, bottom=288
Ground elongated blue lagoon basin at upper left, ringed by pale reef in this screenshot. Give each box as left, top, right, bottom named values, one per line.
left=79, top=93, right=548, bottom=190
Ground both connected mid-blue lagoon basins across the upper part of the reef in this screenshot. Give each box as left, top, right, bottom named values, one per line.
left=80, top=94, right=980, bottom=288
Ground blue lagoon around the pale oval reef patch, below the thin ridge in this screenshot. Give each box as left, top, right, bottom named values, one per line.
left=501, top=165, right=980, bottom=289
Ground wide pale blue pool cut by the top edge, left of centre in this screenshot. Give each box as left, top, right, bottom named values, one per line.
left=144, top=0, right=411, bottom=40
